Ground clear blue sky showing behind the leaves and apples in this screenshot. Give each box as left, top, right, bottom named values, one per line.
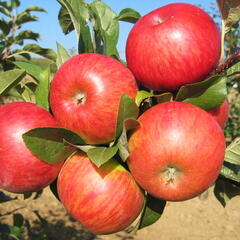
left=19, top=0, right=217, bottom=57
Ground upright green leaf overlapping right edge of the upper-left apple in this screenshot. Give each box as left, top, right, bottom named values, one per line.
left=115, top=94, right=139, bottom=139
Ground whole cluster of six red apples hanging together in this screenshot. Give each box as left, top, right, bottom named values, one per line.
left=0, top=3, right=228, bottom=234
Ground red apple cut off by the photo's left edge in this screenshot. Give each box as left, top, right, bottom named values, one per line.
left=0, top=102, right=62, bottom=193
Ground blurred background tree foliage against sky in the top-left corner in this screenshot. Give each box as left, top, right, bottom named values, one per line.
left=0, top=0, right=56, bottom=70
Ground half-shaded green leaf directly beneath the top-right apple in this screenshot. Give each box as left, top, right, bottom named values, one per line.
left=175, top=75, right=227, bottom=110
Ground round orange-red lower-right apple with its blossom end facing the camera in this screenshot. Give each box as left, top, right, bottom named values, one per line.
left=128, top=102, right=226, bottom=201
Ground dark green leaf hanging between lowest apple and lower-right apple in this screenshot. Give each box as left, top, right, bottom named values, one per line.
left=137, top=194, right=166, bottom=229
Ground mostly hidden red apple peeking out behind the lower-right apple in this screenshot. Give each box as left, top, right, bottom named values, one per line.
left=207, top=100, right=229, bottom=128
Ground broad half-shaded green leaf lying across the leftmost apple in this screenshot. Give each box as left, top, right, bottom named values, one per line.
left=23, top=127, right=85, bottom=164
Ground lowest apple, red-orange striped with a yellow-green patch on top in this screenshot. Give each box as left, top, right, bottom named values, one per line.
left=57, top=154, right=144, bottom=234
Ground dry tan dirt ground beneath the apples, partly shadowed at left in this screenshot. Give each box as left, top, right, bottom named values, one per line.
left=0, top=188, right=240, bottom=240
